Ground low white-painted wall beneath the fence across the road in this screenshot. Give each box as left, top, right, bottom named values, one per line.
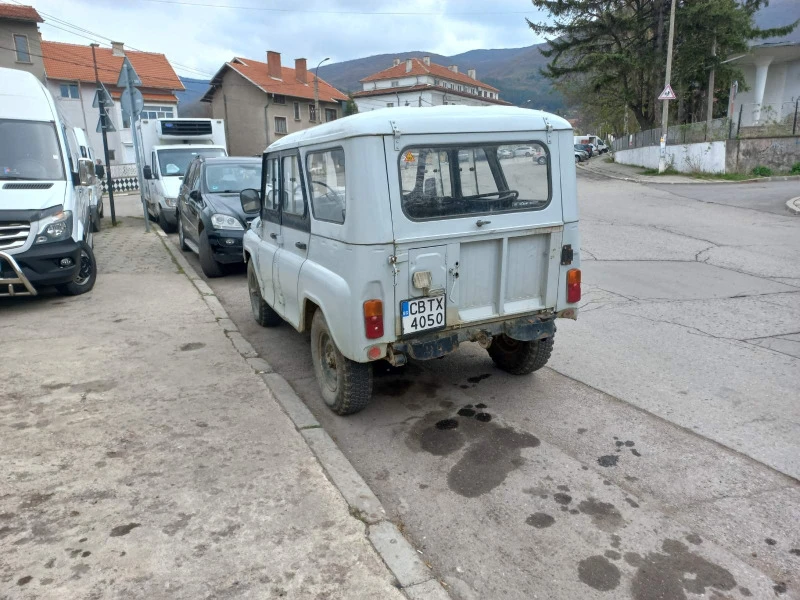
left=614, top=142, right=726, bottom=173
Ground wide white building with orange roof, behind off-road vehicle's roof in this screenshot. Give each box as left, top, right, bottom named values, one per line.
left=353, top=56, right=510, bottom=112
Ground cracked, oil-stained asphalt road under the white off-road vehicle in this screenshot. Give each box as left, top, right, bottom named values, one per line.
left=162, top=174, right=800, bottom=600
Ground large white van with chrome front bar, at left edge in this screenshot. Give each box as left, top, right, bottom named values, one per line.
left=0, top=68, right=97, bottom=296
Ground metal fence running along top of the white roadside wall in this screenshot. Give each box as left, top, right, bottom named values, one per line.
left=611, top=100, right=800, bottom=151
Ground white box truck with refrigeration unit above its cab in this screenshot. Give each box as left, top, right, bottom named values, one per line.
left=137, top=119, right=228, bottom=233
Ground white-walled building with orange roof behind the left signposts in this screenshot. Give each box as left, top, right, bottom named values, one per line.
left=41, top=41, right=184, bottom=165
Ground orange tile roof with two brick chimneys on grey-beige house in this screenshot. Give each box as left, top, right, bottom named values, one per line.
left=203, top=56, right=347, bottom=102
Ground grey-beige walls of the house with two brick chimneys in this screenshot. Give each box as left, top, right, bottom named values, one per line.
left=211, top=69, right=342, bottom=156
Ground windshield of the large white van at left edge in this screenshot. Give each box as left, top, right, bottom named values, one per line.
left=0, top=119, right=64, bottom=181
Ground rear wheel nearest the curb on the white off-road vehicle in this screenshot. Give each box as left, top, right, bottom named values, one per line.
left=311, top=310, right=372, bottom=415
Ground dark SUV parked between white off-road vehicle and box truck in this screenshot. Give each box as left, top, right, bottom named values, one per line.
left=178, top=156, right=261, bottom=277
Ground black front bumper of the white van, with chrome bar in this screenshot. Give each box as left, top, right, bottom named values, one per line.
left=0, top=240, right=81, bottom=296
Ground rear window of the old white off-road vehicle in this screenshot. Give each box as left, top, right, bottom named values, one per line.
left=399, top=142, right=550, bottom=220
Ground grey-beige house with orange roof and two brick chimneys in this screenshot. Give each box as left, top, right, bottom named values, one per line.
left=203, top=50, right=347, bottom=156
